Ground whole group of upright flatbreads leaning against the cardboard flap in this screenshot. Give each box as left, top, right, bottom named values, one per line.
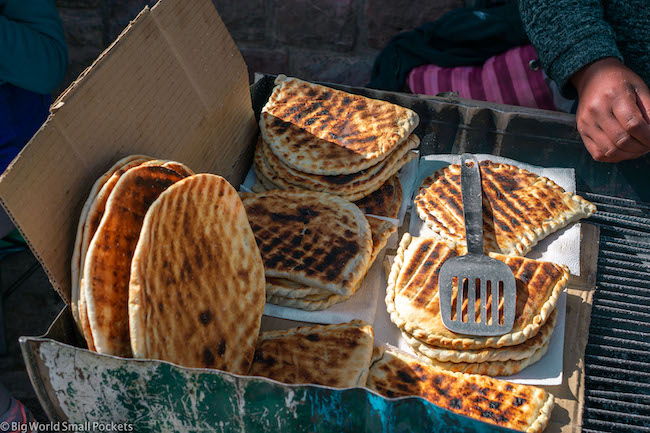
left=72, top=156, right=264, bottom=374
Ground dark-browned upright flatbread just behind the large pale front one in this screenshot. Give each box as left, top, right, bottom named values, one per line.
left=82, top=166, right=183, bottom=356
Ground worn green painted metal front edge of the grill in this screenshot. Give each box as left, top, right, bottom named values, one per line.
left=21, top=309, right=511, bottom=433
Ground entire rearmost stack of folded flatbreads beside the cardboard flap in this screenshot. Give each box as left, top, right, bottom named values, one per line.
left=254, top=75, right=420, bottom=201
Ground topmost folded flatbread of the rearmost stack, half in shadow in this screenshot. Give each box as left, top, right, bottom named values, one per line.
left=260, top=75, right=419, bottom=175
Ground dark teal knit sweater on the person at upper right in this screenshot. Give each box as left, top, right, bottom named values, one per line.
left=519, top=0, right=650, bottom=97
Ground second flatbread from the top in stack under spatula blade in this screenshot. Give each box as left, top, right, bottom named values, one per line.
left=402, top=309, right=557, bottom=364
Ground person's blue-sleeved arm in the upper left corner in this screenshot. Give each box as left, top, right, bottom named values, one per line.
left=0, top=0, right=68, bottom=94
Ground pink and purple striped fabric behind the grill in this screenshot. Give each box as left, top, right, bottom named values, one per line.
left=408, top=45, right=556, bottom=110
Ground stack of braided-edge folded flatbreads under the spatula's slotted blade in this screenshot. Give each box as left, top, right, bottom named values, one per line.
left=386, top=233, right=569, bottom=376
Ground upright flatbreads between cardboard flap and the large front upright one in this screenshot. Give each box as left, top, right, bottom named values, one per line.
left=71, top=155, right=193, bottom=356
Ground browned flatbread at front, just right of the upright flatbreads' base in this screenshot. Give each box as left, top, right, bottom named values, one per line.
left=249, top=320, right=374, bottom=388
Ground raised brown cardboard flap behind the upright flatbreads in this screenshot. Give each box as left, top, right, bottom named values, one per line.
left=0, top=0, right=257, bottom=303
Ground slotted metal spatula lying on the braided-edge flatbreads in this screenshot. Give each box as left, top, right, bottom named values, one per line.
left=438, top=153, right=517, bottom=336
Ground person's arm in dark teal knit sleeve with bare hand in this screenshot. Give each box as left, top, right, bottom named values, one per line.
left=519, top=0, right=650, bottom=162
